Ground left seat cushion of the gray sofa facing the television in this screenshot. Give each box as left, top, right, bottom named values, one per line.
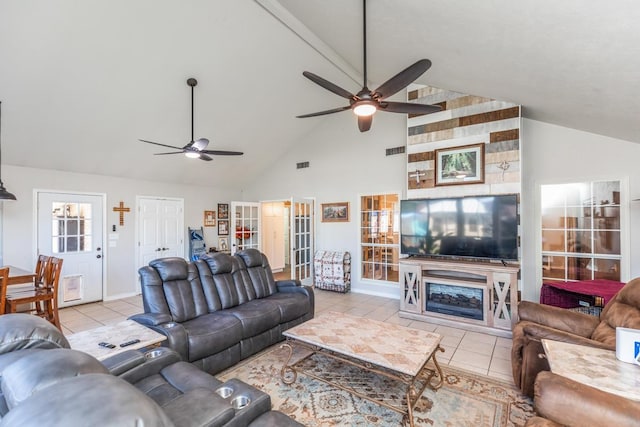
left=182, top=312, right=243, bottom=362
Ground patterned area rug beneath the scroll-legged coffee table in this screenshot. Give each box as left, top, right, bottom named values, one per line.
left=217, top=345, right=534, bottom=427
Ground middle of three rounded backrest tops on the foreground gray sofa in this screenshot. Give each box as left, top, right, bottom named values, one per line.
left=2, top=349, right=109, bottom=410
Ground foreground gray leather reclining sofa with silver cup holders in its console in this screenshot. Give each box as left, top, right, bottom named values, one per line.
left=0, top=314, right=301, bottom=427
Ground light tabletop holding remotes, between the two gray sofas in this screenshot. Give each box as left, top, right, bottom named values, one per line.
left=66, top=320, right=167, bottom=360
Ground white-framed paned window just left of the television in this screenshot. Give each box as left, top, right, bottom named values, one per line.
left=360, top=194, right=400, bottom=283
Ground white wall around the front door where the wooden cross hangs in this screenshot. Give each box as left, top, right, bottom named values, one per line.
left=2, top=166, right=241, bottom=299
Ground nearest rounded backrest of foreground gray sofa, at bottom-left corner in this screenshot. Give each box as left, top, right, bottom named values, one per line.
left=0, top=376, right=174, bottom=427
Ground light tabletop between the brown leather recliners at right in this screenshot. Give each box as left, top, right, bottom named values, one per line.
left=542, top=339, right=640, bottom=400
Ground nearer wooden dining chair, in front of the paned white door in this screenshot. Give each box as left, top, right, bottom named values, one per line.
left=0, top=257, right=63, bottom=329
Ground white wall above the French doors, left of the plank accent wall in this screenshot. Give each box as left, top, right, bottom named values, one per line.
left=244, top=111, right=406, bottom=298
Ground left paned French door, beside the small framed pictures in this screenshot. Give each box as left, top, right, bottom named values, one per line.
left=229, top=202, right=261, bottom=255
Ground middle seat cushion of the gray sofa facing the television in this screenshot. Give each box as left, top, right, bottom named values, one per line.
left=221, top=299, right=280, bottom=342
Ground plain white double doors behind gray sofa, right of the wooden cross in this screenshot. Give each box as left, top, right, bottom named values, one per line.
left=137, top=197, right=184, bottom=268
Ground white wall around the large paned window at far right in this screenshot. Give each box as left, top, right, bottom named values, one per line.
left=520, top=119, right=640, bottom=301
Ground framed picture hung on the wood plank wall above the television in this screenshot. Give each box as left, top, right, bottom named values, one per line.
left=435, top=143, right=484, bottom=185
